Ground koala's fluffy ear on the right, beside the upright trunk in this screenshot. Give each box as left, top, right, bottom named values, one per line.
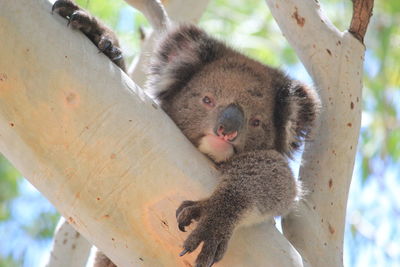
left=275, top=81, right=321, bottom=157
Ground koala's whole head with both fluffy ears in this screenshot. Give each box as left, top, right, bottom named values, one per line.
left=147, top=25, right=319, bottom=162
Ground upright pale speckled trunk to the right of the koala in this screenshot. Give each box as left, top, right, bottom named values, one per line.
left=266, top=0, right=365, bottom=266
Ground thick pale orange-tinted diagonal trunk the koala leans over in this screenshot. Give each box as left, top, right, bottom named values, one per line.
left=0, top=0, right=301, bottom=266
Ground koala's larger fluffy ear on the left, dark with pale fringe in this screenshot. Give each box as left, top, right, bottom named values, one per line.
left=147, top=24, right=226, bottom=101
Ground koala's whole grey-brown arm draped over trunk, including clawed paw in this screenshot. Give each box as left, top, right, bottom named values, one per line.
left=177, top=150, right=300, bottom=266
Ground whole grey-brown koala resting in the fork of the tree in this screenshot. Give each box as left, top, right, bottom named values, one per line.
left=53, top=0, right=320, bottom=267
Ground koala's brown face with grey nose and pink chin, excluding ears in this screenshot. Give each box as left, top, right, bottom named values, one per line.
left=164, top=58, right=282, bottom=162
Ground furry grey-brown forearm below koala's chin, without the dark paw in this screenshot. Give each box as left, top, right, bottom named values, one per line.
left=219, top=150, right=300, bottom=216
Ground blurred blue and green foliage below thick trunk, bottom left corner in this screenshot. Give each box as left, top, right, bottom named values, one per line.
left=0, top=155, right=60, bottom=267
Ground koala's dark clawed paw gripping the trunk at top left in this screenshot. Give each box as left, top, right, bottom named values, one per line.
left=52, top=0, right=125, bottom=71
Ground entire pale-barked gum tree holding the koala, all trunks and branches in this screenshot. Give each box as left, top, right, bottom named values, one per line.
left=0, top=0, right=373, bottom=266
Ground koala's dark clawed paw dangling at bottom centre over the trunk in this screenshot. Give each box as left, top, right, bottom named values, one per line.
left=176, top=201, right=233, bottom=267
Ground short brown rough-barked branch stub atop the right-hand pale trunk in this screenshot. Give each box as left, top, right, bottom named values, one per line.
left=349, top=0, right=374, bottom=43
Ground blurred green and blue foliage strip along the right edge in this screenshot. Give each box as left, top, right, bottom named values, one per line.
left=345, top=1, right=400, bottom=266
